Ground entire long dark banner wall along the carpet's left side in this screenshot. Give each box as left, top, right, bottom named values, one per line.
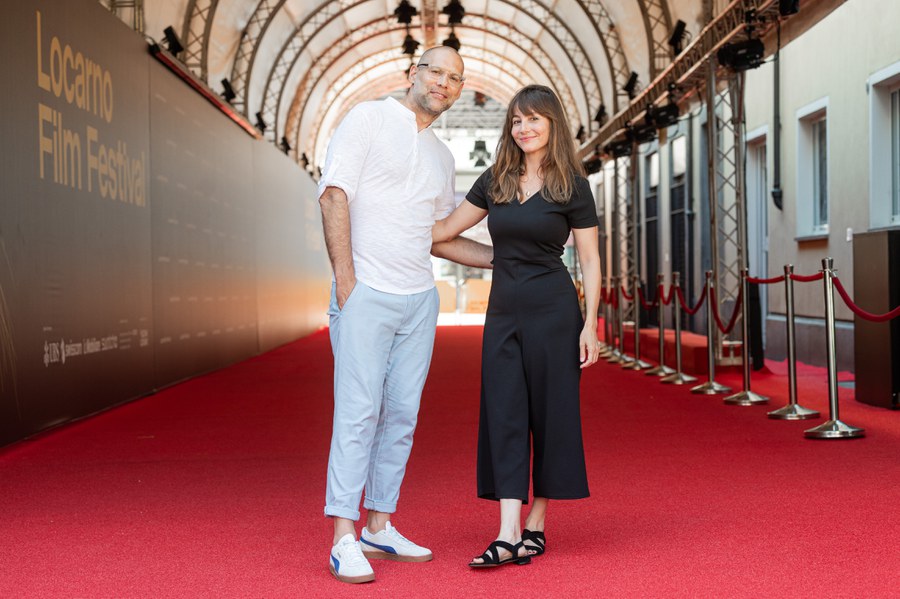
left=0, top=0, right=330, bottom=445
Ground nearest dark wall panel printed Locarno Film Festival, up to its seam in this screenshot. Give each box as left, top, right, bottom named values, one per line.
left=0, top=0, right=153, bottom=442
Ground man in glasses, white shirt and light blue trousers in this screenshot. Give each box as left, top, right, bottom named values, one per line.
left=319, top=47, right=492, bottom=583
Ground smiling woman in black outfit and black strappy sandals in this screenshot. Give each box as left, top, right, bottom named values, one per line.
left=433, top=85, right=600, bottom=568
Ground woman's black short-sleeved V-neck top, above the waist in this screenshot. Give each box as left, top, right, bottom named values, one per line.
left=466, top=168, right=599, bottom=265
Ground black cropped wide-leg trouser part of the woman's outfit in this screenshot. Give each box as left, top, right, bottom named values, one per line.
left=477, top=259, right=589, bottom=503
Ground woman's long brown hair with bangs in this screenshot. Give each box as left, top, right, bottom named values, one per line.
left=488, top=85, right=584, bottom=204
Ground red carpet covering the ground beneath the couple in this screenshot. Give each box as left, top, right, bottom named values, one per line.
left=0, top=327, right=900, bottom=598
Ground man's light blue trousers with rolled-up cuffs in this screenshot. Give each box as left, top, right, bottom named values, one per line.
left=325, top=281, right=440, bottom=520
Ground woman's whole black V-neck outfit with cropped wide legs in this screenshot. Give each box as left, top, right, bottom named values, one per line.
left=466, top=169, right=598, bottom=503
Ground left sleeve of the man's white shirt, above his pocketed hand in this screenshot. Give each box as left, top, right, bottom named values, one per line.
left=318, top=104, right=377, bottom=202
